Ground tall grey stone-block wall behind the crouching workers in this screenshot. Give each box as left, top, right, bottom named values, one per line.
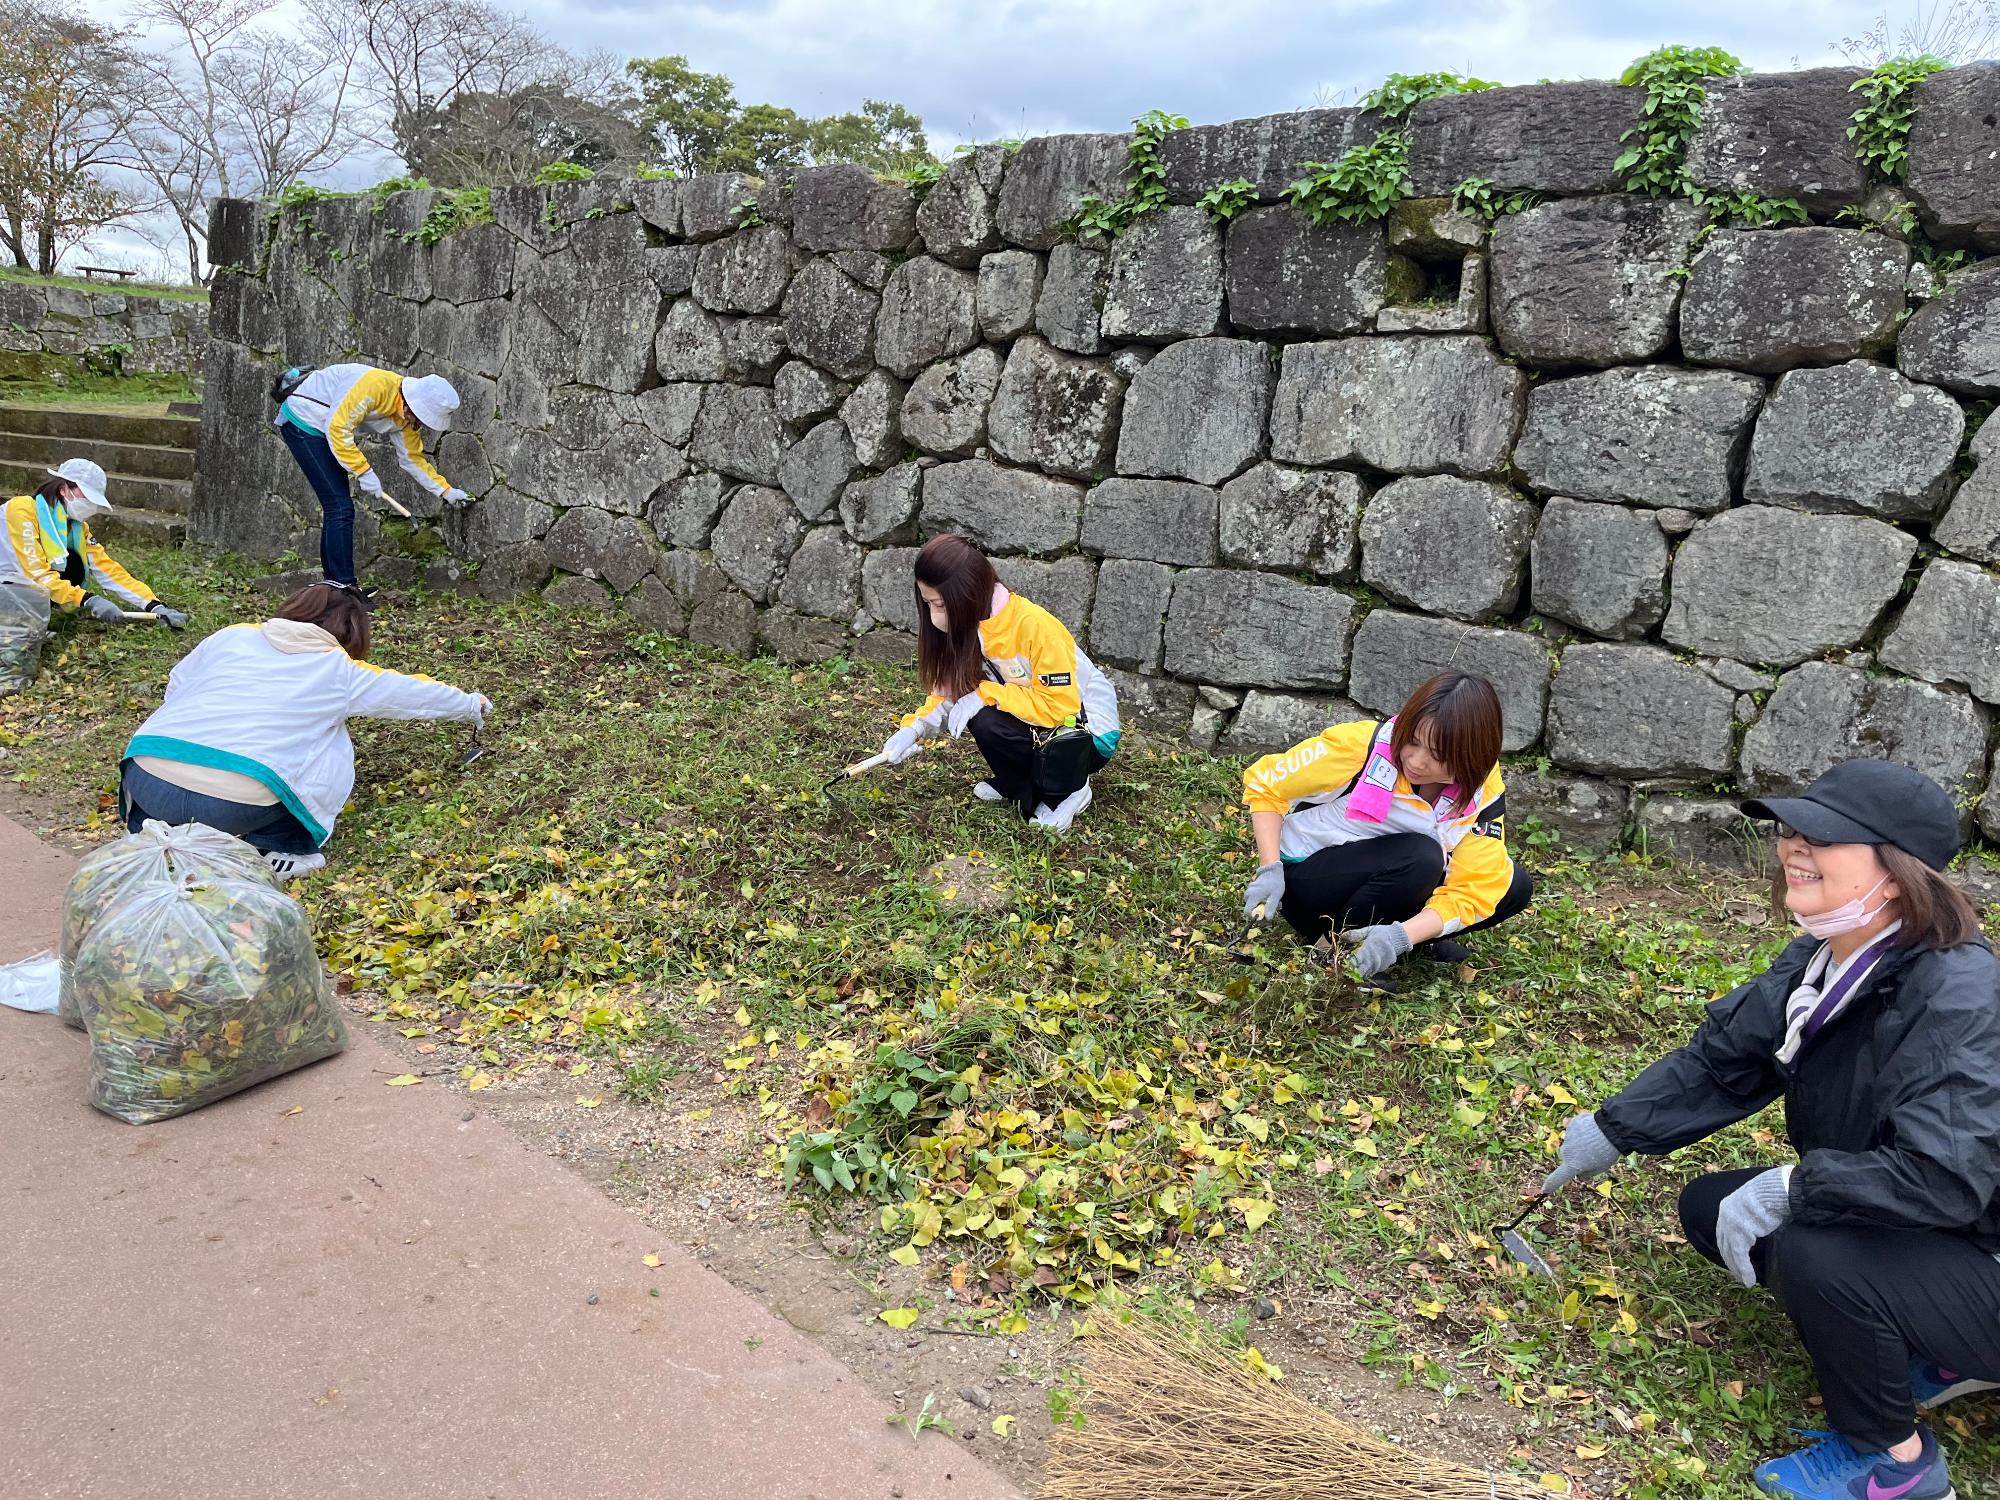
left=194, top=64, right=2000, bottom=854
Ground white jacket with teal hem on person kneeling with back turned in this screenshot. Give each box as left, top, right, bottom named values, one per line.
left=126, top=620, right=484, bottom=844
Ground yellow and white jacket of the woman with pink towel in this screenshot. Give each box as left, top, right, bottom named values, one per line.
left=1244, top=722, right=1514, bottom=932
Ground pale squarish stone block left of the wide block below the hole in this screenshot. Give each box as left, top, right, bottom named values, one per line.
left=1118, top=338, right=1272, bottom=484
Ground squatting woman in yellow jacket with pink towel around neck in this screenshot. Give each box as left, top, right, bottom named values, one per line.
left=1244, top=672, right=1534, bottom=978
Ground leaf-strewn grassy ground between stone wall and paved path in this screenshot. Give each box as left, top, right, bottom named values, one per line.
left=0, top=552, right=2000, bottom=1496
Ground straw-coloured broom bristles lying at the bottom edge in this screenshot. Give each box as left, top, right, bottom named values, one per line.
left=1042, top=1312, right=1548, bottom=1500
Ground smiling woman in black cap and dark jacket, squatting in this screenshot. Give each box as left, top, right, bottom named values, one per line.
left=1542, top=760, right=2000, bottom=1500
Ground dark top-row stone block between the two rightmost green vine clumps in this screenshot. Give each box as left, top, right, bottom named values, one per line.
left=1688, top=68, right=1868, bottom=216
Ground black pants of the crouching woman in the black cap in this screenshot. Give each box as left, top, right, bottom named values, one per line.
left=1680, top=1168, right=2000, bottom=1454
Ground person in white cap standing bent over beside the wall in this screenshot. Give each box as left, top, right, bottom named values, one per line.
left=272, top=364, right=468, bottom=588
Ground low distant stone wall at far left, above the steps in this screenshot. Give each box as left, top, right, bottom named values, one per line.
left=0, top=282, right=208, bottom=388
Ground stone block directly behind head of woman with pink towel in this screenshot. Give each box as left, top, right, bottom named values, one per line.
left=1348, top=610, right=1556, bottom=754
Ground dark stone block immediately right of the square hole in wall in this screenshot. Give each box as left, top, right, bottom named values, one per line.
left=1490, top=194, right=1708, bottom=366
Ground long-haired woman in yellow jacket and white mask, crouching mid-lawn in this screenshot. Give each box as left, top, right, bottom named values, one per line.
left=882, top=534, right=1118, bottom=830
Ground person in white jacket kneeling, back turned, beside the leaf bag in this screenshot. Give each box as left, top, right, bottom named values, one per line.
left=122, top=584, right=492, bottom=878
